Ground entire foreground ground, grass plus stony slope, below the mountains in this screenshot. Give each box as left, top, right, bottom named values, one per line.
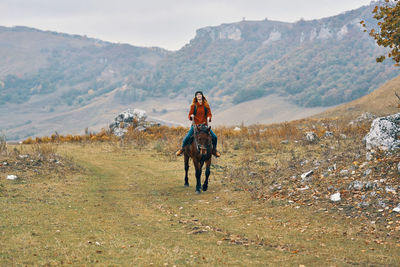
left=0, top=120, right=400, bottom=266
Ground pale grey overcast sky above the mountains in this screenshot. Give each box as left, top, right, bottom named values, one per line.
left=0, top=0, right=371, bottom=50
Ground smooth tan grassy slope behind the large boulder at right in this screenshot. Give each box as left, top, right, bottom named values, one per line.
left=316, top=73, right=400, bottom=118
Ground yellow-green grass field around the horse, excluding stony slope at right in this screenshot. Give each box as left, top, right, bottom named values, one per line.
left=0, top=121, right=400, bottom=266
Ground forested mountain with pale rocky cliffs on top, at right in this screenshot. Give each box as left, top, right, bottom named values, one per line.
left=132, top=3, right=400, bottom=107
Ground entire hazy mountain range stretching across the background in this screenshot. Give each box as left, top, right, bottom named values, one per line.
left=0, top=5, right=400, bottom=139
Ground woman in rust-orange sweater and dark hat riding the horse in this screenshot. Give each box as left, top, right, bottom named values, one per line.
left=176, top=91, right=221, bottom=157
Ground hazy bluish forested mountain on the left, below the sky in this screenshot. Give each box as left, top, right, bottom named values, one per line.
left=0, top=27, right=168, bottom=107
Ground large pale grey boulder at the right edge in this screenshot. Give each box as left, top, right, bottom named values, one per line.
left=364, top=113, right=400, bottom=151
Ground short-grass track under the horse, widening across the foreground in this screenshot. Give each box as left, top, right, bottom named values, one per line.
left=0, top=145, right=400, bottom=266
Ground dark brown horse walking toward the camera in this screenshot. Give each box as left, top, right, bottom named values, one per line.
left=184, top=124, right=213, bottom=194
